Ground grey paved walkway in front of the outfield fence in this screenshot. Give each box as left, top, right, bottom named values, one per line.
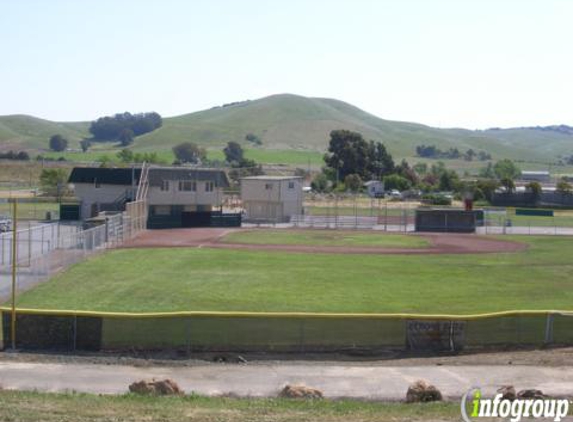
left=0, top=362, right=573, bottom=401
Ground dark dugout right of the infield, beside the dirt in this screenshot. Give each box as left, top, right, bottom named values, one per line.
left=416, top=208, right=484, bottom=233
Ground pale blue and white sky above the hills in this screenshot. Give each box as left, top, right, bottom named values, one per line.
left=0, top=0, right=573, bottom=128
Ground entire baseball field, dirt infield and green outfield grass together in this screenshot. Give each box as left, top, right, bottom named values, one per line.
left=12, top=229, right=573, bottom=314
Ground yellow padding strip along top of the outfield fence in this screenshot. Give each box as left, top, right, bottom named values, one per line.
left=0, top=307, right=573, bottom=321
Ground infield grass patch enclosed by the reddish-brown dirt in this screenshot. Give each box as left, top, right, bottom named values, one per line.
left=221, top=230, right=429, bottom=248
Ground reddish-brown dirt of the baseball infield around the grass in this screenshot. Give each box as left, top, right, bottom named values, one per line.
left=122, top=228, right=527, bottom=255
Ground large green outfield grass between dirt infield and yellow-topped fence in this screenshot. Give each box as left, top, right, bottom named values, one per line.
left=12, top=237, right=573, bottom=314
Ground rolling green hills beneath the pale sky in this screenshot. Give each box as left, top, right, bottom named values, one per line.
left=0, top=94, right=573, bottom=162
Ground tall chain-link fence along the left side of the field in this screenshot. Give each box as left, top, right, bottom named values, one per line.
left=0, top=201, right=147, bottom=300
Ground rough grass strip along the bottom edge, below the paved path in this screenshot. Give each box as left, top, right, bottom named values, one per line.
left=0, top=391, right=460, bottom=422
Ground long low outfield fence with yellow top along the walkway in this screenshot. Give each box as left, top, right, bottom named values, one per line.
left=0, top=308, right=573, bottom=354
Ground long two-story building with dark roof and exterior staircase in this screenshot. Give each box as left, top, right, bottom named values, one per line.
left=68, top=167, right=229, bottom=228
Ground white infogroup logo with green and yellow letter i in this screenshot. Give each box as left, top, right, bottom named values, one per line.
left=461, top=387, right=570, bottom=422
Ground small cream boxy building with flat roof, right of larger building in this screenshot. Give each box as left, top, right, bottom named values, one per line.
left=241, top=176, right=303, bottom=223
